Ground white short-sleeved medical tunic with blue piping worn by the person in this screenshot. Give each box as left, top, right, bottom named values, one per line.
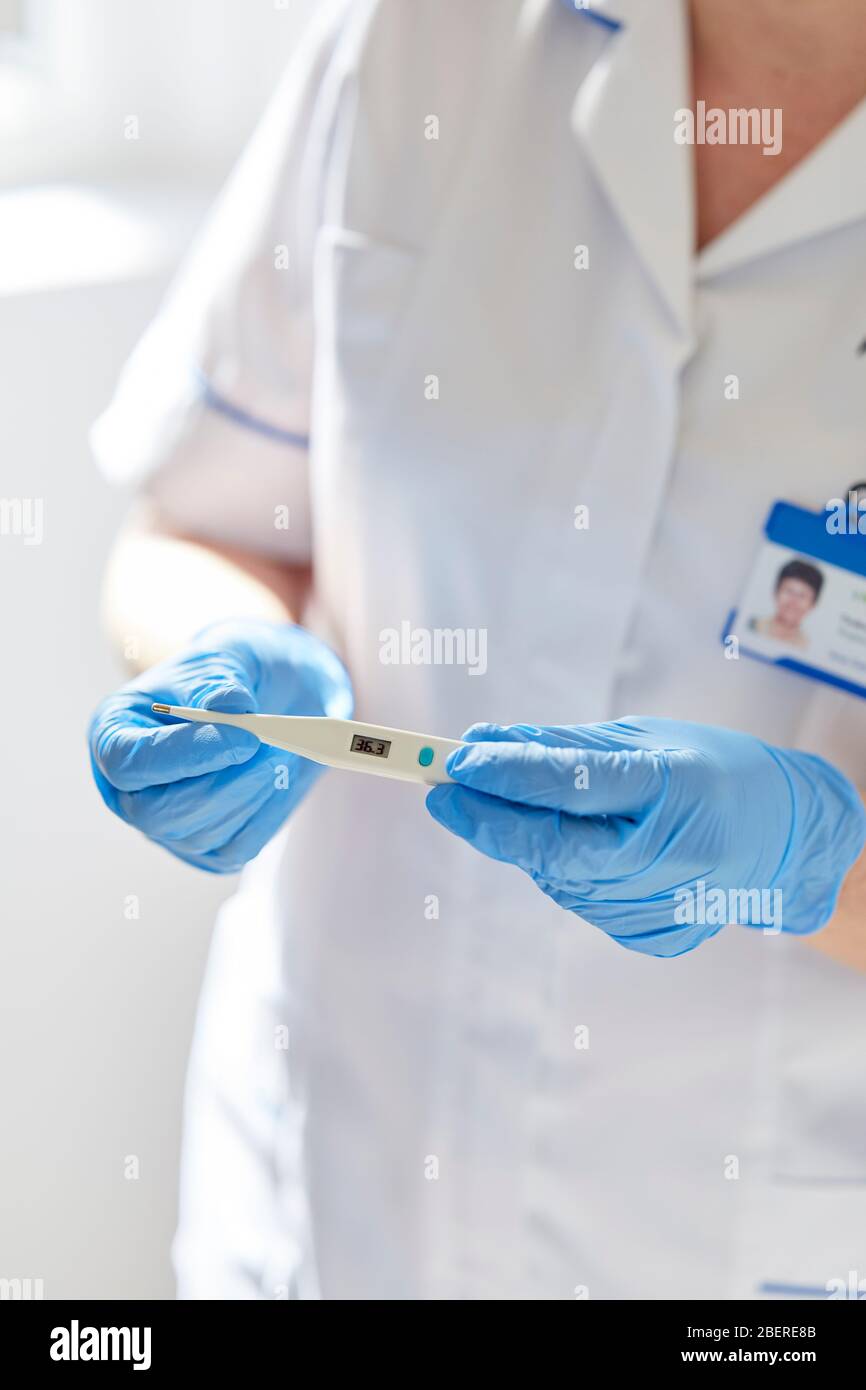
left=95, top=0, right=866, bottom=1298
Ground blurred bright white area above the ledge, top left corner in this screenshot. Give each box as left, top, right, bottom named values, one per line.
left=0, top=0, right=314, bottom=183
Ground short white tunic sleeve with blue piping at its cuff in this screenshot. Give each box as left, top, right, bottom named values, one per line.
left=92, top=0, right=350, bottom=563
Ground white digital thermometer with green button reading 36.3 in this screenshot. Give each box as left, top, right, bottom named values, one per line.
left=152, top=705, right=463, bottom=785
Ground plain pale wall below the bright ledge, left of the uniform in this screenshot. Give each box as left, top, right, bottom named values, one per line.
left=0, top=273, right=233, bottom=1298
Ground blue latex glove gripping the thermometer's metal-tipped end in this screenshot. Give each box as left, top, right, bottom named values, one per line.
left=89, top=620, right=352, bottom=873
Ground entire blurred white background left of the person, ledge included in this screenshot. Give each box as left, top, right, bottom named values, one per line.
left=0, top=0, right=313, bottom=1298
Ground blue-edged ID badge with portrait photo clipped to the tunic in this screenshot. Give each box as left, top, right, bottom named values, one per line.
left=723, top=502, right=866, bottom=696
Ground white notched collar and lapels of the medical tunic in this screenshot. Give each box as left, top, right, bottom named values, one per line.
left=567, top=0, right=866, bottom=312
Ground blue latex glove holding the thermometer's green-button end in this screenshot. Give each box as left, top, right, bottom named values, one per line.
left=427, top=717, right=866, bottom=956
